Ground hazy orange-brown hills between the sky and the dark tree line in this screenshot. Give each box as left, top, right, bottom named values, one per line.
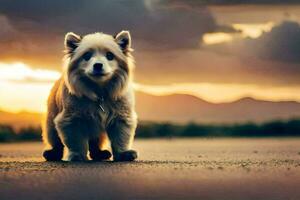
left=0, top=92, right=300, bottom=128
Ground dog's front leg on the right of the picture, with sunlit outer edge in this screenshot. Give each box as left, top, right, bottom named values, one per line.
left=107, top=118, right=137, bottom=161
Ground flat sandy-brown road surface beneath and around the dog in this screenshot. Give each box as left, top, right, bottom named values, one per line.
left=0, top=138, right=300, bottom=200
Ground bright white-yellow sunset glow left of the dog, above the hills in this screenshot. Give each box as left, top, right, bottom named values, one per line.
left=0, top=62, right=60, bottom=112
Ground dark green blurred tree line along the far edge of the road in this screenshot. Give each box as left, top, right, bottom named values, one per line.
left=0, top=119, right=300, bottom=142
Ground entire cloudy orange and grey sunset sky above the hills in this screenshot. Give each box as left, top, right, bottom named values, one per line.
left=0, top=0, right=300, bottom=112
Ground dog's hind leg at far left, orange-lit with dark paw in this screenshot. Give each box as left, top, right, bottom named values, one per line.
left=43, top=114, right=64, bottom=161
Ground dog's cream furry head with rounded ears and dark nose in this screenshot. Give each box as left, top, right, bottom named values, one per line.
left=64, top=31, right=133, bottom=100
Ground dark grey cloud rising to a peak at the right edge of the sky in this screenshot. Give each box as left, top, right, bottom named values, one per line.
left=208, top=21, right=300, bottom=62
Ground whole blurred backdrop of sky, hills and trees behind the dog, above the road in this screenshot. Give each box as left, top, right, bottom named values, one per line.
left=0, top=0, right=300, bottom=142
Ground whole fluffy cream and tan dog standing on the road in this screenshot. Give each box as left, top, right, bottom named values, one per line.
left=43, top=31, right=137, bottom=161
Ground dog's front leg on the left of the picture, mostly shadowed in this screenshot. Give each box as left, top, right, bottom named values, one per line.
left=55, top=112, right=88, bottom=161
